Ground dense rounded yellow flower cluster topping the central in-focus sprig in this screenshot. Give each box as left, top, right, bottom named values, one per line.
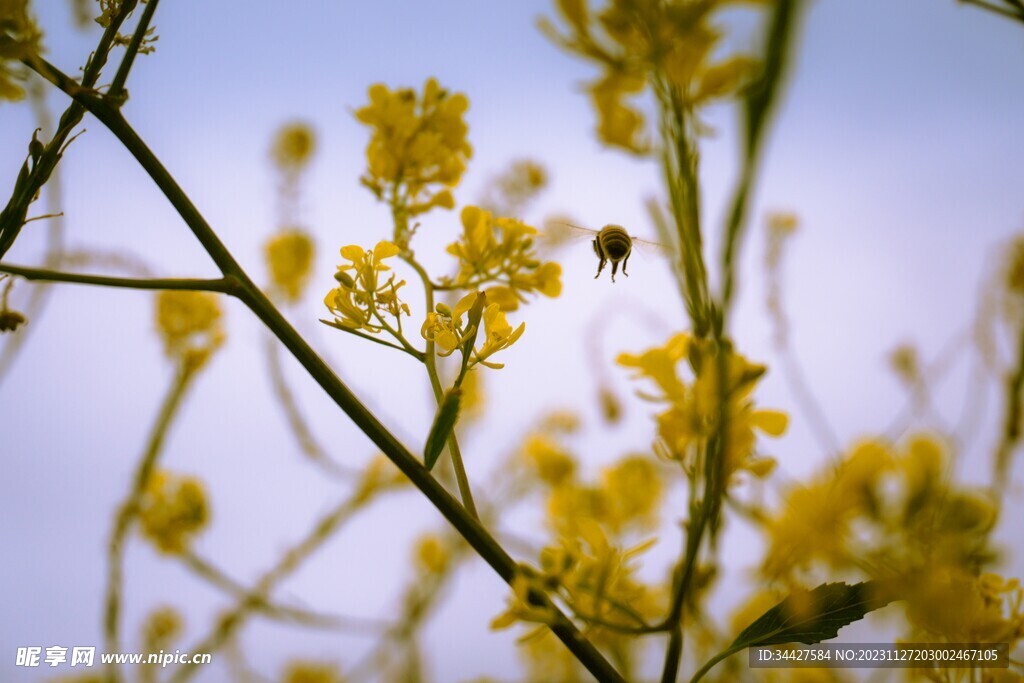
left=355, top=79, right=473, bottom=215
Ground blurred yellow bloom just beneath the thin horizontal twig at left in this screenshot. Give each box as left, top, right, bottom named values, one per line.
left=157, top=291, right=224, bottom=365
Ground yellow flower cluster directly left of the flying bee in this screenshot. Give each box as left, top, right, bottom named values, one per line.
left=447, top=206, right=562, bottom=310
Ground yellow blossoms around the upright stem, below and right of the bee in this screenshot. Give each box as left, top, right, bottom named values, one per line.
left=617, top=333, right=788, bottom=481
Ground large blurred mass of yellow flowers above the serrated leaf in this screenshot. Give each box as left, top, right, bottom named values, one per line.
left=761, top=435, right=1024, bottom=655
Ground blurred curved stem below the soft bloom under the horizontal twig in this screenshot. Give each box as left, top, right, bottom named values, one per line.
left=103, top=364, right=197, bottom=683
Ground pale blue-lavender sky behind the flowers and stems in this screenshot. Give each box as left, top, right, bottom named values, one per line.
left=0, top=0, right=1024, bottom=682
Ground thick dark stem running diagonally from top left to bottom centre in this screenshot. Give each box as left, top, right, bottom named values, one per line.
left=28, top=54, right=623, bottom=683
